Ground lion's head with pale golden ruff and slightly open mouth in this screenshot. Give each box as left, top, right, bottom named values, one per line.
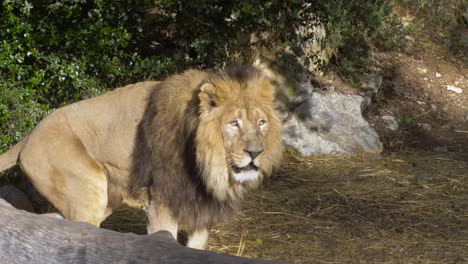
left=196, top=67, right=282, bottom=200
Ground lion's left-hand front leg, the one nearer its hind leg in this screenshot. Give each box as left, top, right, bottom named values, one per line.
left=146, top=201, right=179, bottom=240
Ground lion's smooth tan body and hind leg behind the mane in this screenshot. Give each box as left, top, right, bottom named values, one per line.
left=0, top=82, right=157, bottom=226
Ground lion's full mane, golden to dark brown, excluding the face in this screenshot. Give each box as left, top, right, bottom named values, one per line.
left=131, top=67, right=282, bottom=228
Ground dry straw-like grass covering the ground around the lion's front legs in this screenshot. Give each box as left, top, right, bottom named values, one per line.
left=102, top=152, right=468, bottom=263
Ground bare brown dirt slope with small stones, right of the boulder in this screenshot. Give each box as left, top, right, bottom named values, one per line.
left=368, top=36, right=468, bottom=156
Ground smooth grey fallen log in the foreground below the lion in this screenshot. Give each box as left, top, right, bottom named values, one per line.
left=0, top=199, right=284, bottom=264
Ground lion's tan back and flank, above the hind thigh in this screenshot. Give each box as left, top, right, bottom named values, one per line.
left=28, top=81, right=158, bottom=172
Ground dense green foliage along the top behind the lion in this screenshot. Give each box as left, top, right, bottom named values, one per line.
left=0, top=0, right=391, bottom=152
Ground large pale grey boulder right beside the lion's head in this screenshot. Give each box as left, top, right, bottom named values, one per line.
left=282, top=90, right=382, bottom=156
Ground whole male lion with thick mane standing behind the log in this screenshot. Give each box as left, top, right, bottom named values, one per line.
left=0, top=66, right=282, bottom=248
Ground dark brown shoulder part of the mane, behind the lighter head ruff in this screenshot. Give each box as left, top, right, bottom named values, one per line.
left=129, top=68, right=240, bottom=227
